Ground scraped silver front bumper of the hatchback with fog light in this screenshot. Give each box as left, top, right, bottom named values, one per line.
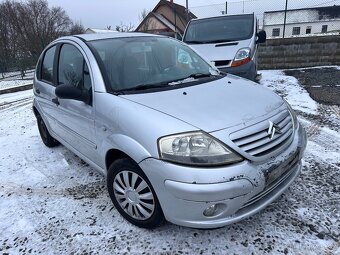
left=140, top=126, right=306, bottom=228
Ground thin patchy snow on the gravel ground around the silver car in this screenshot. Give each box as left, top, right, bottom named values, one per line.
left=0, top=71, right=340, bottom=255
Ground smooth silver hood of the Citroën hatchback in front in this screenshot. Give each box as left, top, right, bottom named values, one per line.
left=120, top=74, right=283, bottom=132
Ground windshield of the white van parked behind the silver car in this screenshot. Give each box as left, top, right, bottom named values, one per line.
left=184, top=14, right=254, bottom=43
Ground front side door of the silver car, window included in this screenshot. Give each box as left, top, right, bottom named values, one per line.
left=56, top=43, right=97, bottom=162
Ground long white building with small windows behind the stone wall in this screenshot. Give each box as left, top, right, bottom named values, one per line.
left=263, top=5, right=340, bottom=38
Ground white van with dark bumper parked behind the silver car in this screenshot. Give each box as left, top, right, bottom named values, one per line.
left=183, top=14, right=266, bottom=80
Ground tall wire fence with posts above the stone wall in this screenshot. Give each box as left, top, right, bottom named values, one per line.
left=189, top=0, right=340, bottom=38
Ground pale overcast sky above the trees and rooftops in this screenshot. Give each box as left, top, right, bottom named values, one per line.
left=0, top=0, right=340, bottom=28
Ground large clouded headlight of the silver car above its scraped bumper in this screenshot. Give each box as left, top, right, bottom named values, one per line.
left=158, top=132, right=243, bottom=166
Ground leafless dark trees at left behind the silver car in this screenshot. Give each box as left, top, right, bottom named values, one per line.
left=0, top=0, right=84, bottom=75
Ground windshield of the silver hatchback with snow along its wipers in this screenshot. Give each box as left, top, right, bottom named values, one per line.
left=88, top=36, right=218, bottom=91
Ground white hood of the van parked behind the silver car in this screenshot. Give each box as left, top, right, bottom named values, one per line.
left=189, top=39, right=251, bottom=61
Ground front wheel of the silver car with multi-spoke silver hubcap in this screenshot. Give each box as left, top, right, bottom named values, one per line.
left=107, top=158, right=164, bottom=229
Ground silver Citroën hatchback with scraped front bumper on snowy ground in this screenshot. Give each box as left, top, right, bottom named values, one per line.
left=33, top=33, right=306, bottom=228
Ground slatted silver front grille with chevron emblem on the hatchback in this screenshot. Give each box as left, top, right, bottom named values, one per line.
left=230, top=110, right=293, bottom=157
